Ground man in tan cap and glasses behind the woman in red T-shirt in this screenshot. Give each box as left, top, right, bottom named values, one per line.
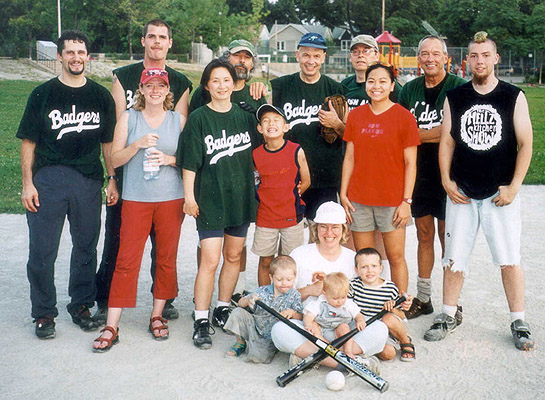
left=341, top=35, right=401, bottom=110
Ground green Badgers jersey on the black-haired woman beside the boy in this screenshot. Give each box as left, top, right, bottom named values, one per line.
left=177, top=104, right=257, bottom=230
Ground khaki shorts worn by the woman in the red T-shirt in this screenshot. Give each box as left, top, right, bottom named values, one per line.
left=350, top=202, right=413, bottom=233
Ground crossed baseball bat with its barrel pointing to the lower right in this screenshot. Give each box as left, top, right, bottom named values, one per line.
left=256, top=300, right=400, bottom=392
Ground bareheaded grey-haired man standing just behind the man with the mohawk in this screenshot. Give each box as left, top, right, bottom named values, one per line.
left=399, top=35, right=465, bottom=325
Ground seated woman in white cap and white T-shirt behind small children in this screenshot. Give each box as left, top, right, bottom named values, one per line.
left=271, top=201, right=388, bottom=368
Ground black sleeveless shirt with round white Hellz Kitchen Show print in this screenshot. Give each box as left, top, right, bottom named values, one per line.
left=447, top=81, right=521, bottom=200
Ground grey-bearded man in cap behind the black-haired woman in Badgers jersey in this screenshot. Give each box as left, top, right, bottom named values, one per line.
left=189, top=39, right=267, bottom=112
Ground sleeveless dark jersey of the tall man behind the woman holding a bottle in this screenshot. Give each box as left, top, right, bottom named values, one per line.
left=113, top=61, right=193, bottom=108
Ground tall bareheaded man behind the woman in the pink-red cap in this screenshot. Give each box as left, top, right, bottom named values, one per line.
left=94, top=19, right=192, bottom=324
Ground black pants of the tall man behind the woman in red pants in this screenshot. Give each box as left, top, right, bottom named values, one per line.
left=96, top=168, right=170, bottom=307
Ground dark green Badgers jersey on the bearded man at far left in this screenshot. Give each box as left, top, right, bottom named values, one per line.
left=17, top=78, right=115, bottom=180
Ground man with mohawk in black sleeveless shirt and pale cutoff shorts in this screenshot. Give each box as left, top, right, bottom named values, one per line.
left=424, top=32, right=535, bottom=350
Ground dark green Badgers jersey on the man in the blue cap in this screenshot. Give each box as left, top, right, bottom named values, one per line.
left=271, top=72, right=343, bottom=188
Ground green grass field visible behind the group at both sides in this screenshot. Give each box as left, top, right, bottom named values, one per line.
left=0, top=79, right=545, bottom=213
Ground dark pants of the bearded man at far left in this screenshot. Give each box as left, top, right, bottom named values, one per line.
left=26, top=166, right=102, bottom=318
